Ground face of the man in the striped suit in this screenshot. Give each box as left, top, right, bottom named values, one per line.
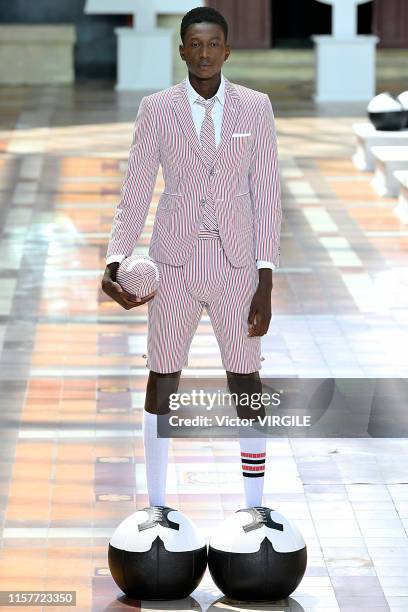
left=179, top=22, right=230, bottom=80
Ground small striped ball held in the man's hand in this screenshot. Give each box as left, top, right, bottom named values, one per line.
left=116, top=255, right=160, bottom=298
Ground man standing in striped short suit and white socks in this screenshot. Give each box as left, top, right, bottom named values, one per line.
left=102, top=7, right=281, bottom=507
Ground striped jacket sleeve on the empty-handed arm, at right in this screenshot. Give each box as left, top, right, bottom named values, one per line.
left=249, top=95, right=282, bottom=267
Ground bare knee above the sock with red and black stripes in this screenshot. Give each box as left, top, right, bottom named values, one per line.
left=226, top=371, right=265, bottom=419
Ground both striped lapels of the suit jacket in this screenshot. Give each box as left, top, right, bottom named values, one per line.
left=172, top=77, right=241, bottom=165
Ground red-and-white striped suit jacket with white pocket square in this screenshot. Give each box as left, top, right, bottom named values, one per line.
left=106, top=79, right=282, bottom=267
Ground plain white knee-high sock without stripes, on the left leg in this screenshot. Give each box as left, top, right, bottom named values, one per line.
left=143, top=410, right=170, bottom=506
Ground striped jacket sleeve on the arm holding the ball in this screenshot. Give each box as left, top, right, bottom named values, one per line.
left=106, top=97, right=160, bottom=258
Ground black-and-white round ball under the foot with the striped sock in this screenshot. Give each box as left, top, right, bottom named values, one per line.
left=208, top=507, right=307, bottom=601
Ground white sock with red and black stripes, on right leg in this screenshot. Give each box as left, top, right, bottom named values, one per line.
left=239, top=437, right=266, bottom=508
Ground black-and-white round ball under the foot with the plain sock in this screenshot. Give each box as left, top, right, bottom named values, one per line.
left=108, top=506, right=207, bottom=600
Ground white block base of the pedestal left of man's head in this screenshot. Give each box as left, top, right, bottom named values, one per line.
left=115, top=28, right=173, bottom=91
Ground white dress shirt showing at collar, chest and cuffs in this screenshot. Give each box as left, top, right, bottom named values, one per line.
left=106, top=72, right=275, bottom=269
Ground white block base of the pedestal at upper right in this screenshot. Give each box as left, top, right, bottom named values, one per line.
left=312, top=36, right=379, bottom=102
